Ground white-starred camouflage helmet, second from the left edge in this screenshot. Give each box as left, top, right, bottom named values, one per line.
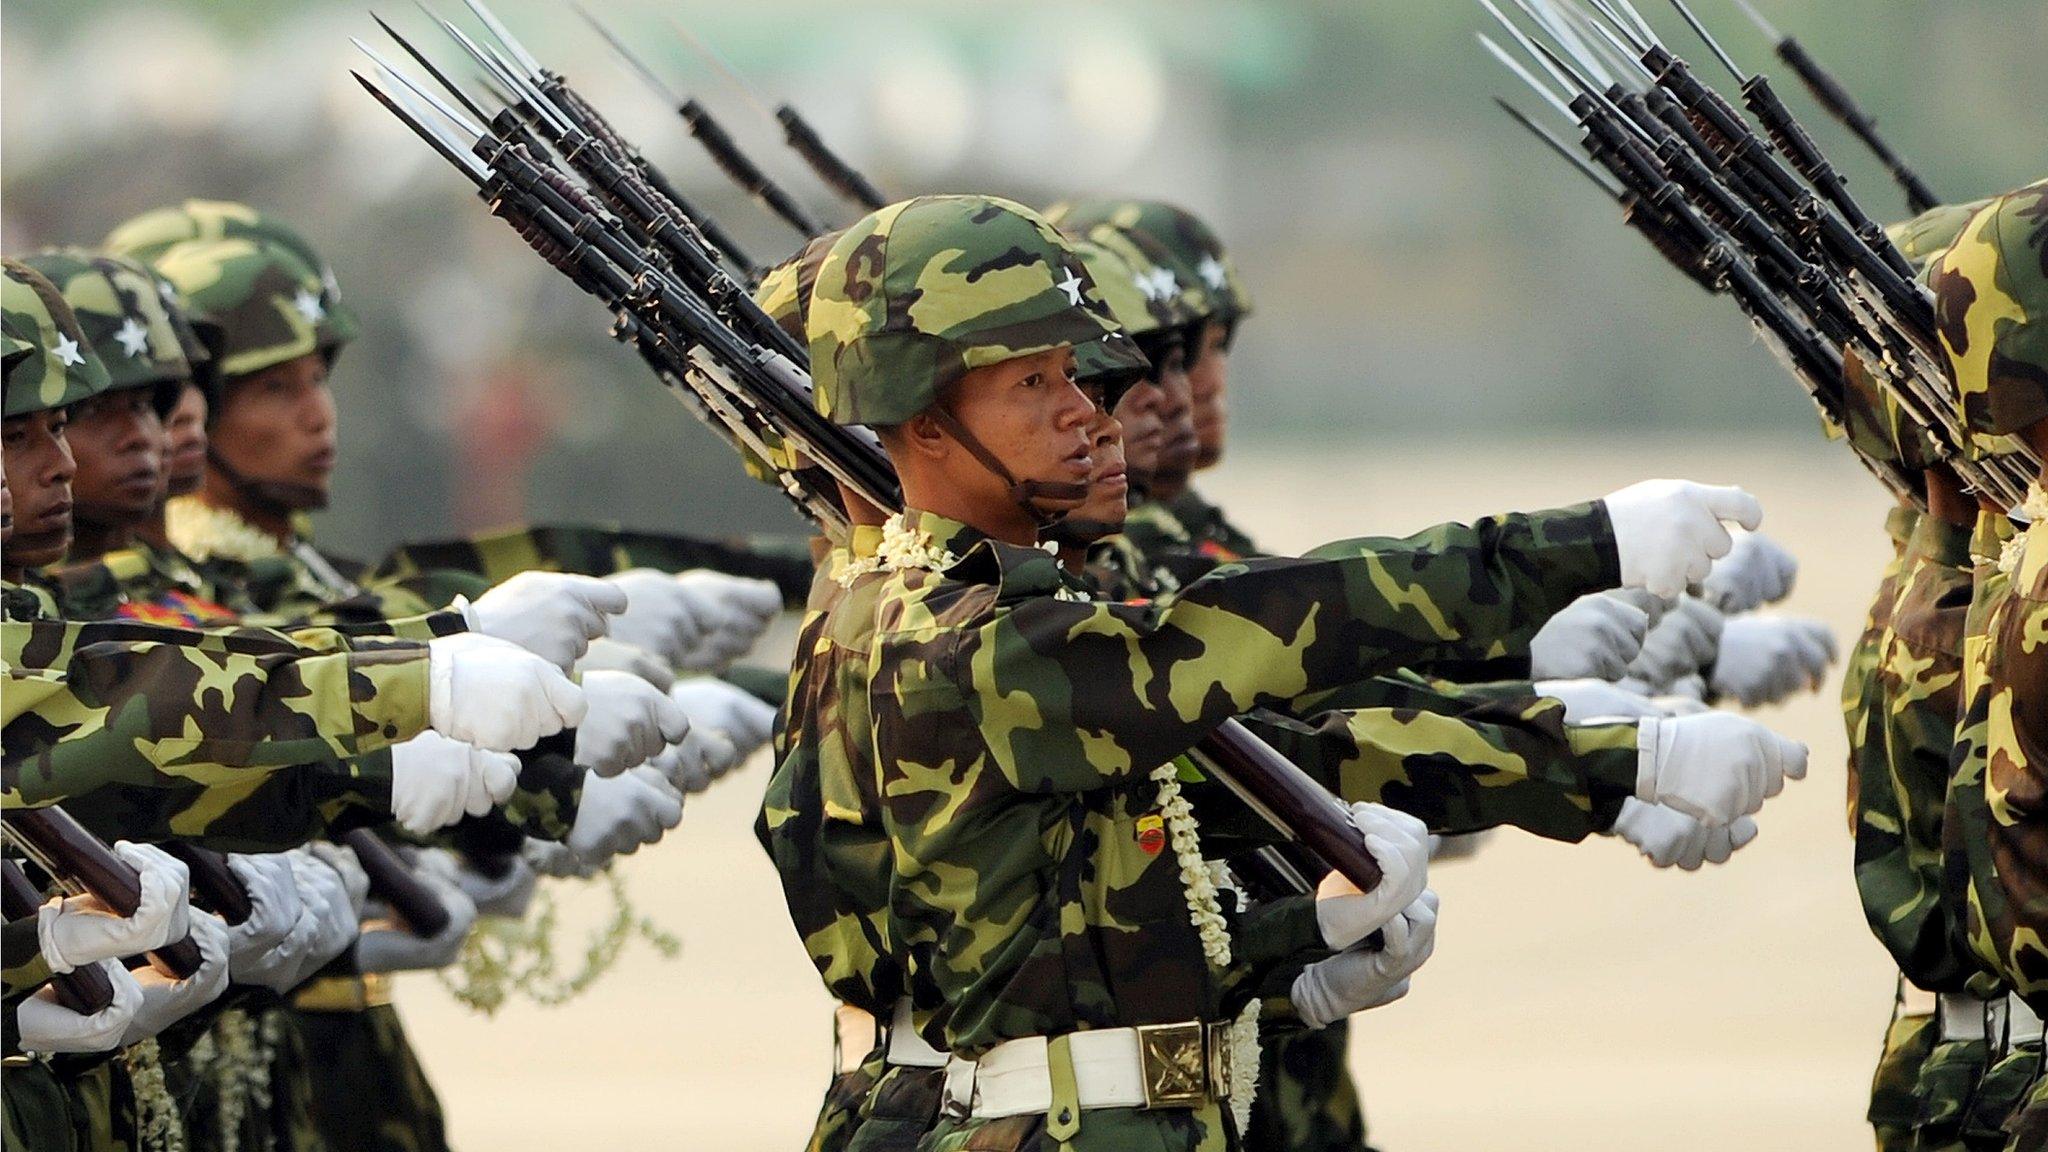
left=23, top=248, right=193, bottom=416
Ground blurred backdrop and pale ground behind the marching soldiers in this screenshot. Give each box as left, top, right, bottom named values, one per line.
left=0, top=0, right=2048, bottom=1150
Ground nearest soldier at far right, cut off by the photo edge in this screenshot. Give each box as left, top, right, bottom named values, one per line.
left=1931, top=180, right=2048, bottom=1150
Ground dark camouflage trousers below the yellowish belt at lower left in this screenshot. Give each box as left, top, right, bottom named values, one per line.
left=291, top=1004, right=449, bottom=1152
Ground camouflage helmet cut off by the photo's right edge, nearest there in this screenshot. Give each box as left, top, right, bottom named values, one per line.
left=1931, top=180, right=2048, bottom=440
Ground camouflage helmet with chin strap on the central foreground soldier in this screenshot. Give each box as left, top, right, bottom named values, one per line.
left=805, top=197, right=1145, bottom=424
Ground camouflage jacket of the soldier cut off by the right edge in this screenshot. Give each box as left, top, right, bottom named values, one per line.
left=1964, top=512, right=2048, bottom=1013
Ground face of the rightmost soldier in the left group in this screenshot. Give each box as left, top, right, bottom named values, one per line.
left=209, top=353, right=336, bottom=508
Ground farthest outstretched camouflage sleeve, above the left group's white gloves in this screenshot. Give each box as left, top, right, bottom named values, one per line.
left=369, top=525, right=813, bottom=609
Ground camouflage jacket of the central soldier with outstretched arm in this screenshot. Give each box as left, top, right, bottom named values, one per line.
left=868, top=498, right=1618, bottom=1054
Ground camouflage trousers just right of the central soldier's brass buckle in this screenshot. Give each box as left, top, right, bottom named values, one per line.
left=1245, top=1021, right=1366, bottom=1152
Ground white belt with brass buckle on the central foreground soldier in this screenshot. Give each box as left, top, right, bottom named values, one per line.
left=946, top=1021, right=1257, bottom=1119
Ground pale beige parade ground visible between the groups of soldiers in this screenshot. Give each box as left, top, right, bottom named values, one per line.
left=399, top=433, right=1892, bottom=1152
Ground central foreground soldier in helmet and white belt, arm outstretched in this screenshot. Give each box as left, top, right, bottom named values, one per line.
left=809, top=197, right=1796, bottom=1146
